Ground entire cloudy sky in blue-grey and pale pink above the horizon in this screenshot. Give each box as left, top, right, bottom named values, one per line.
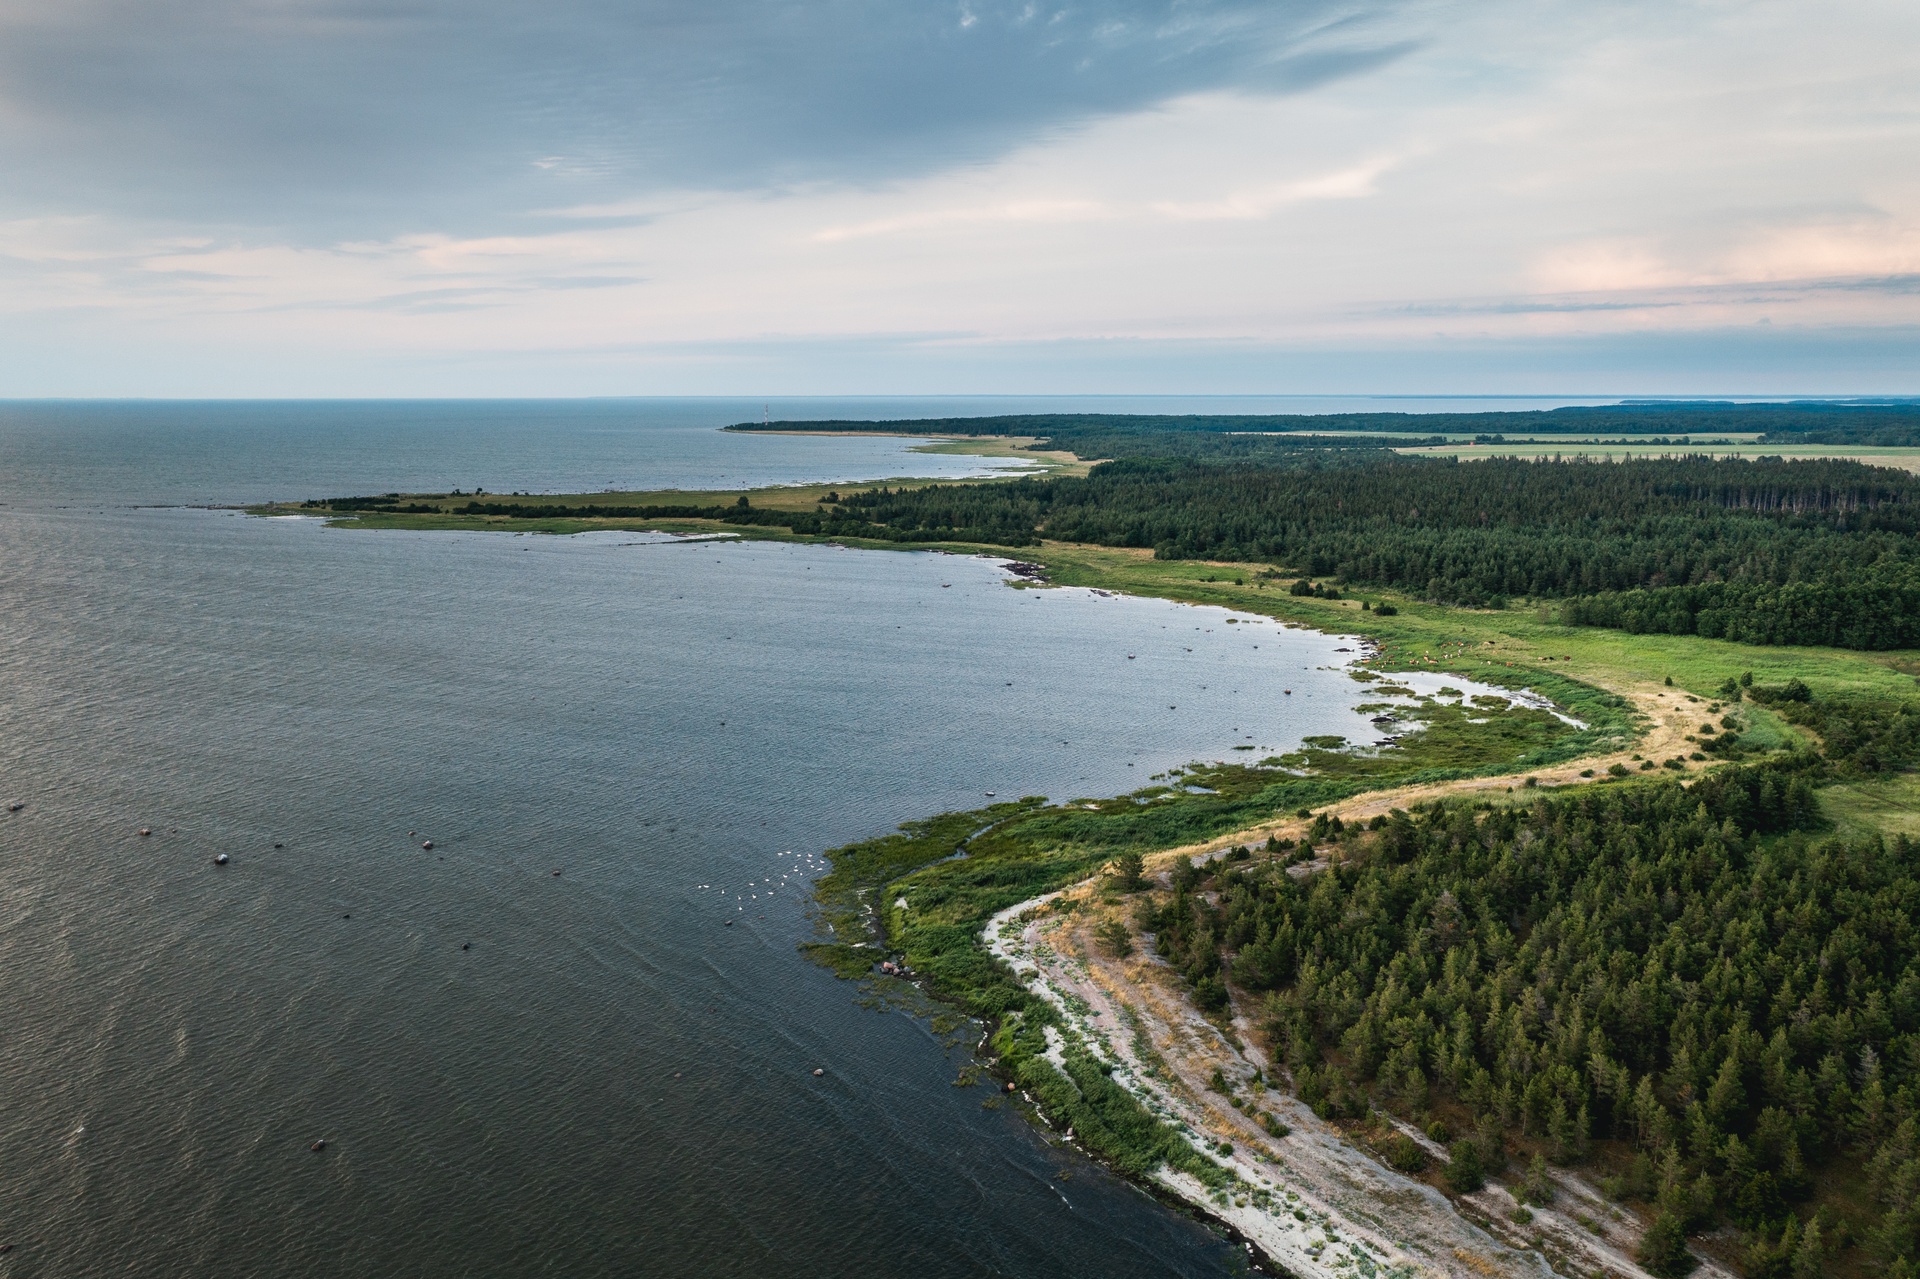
left=0, top=0, right=1920, bottom=396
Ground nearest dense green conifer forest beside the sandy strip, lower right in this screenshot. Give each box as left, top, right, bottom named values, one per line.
left=1146, top=756, right=1920, bottom=1275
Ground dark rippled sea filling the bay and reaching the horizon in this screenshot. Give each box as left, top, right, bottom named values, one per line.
left=0, top=393, right=1528, bottom=1277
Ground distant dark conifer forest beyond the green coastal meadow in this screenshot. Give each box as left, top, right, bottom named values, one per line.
left=802, top=453, right=1920, bottom=649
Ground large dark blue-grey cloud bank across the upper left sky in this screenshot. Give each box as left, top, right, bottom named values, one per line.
left=0, top=0, right=1405, bottom=238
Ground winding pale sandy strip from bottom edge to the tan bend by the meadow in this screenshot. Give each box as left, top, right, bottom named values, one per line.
left=810, top=557, right=1732, bottom=1279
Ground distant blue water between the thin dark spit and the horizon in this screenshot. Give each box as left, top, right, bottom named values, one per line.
left=0, top=396, right=1597, bottom=503
